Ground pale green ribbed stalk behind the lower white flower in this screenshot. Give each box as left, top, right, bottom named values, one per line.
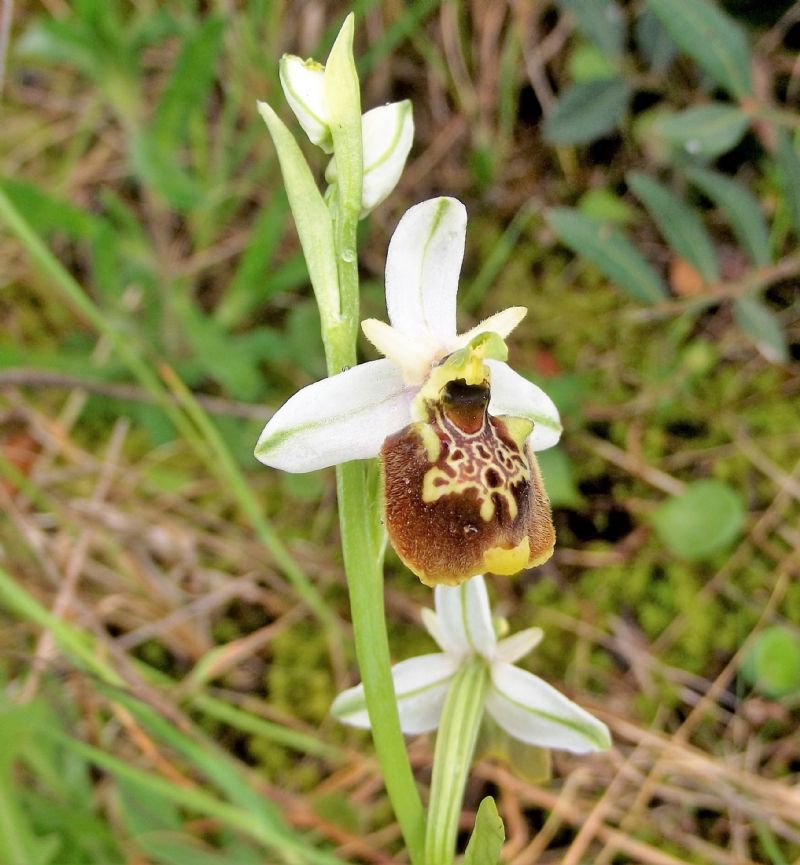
left=425, top=658, right=489, bottom=865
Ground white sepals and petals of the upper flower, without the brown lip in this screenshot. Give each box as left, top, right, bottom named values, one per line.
left=256, top=198, right=561, bottom=472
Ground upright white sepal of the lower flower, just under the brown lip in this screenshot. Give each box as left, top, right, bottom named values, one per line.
left=434, top=574, right=497, bottom=659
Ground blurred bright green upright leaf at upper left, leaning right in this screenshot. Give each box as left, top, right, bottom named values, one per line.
left=151, top=18, right=224, bottom=147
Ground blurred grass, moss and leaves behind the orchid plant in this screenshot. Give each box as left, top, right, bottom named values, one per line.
left=0, top=0, right=800, bottom=865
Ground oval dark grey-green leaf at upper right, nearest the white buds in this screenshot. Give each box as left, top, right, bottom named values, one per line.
left=544, top=78, right=631, bottom=144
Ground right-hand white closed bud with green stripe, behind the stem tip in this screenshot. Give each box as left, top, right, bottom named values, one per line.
left=325, top=99, right=414, bottom=218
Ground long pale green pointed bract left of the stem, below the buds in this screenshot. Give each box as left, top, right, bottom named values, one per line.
left=258, top=102, right=340, bottom=320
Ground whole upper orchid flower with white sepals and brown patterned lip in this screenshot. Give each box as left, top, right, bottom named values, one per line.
left=256, top=198, right=561, bottom=585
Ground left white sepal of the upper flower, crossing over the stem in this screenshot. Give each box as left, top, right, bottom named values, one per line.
left=256, top=360, right=410, bottom=472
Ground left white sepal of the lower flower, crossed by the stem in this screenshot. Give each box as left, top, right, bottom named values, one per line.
left=331, top=654, right=458, bottom=735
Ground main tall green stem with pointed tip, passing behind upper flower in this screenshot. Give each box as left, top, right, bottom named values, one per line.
left=323, top=15, right=425, bottom=865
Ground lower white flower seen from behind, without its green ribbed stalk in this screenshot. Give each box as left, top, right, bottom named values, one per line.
left=331, top=576, right=611, bottom=754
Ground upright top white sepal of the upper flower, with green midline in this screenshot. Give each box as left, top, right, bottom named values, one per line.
left=386, top=198, right=467, bottom=345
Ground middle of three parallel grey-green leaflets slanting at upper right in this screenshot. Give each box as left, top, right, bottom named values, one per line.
left=626, top=171, right=719, bottom=282
